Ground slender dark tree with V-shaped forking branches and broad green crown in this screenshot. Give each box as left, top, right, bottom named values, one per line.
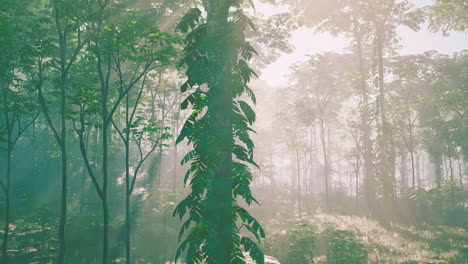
left=73, top=1, right=177, bottom=264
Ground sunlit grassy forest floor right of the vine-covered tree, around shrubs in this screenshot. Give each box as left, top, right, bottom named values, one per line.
left=264, top=212, right=468, bottom=264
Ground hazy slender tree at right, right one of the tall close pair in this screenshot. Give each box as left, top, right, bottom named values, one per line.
left=366, top=0, right=421, bottom=214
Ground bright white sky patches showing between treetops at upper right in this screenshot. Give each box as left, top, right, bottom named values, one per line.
left=256, top=0, right=468, bottom=86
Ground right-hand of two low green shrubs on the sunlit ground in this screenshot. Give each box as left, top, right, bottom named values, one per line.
left=327, top=230, right=368, bottom=264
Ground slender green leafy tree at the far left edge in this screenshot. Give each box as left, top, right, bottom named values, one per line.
left=0, top=1, right=38, bottom=264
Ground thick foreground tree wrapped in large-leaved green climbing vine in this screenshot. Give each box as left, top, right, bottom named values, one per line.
left=174, top=1, right=265, bottom=264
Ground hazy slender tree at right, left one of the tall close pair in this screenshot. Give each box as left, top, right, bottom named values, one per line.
left=299, top=0, right=377, bottom=212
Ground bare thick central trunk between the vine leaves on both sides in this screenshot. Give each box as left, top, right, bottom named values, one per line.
left=205, top=0, right=237, bottom=264
